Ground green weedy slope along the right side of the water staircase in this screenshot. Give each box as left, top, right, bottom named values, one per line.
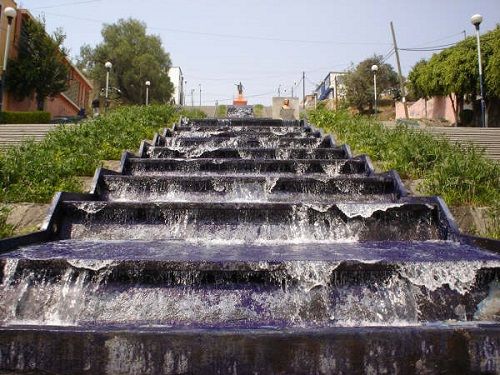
left=309, top=110, right=500, bottom=207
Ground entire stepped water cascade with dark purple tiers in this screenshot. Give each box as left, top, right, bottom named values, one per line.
left=0, top=118, right=500, bottom=374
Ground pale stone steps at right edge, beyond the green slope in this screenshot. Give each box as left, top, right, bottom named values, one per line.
left=384, top=121, right=500, bottom=161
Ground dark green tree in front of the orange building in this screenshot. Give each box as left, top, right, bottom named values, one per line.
left=5, top=19, right=69, bottom=111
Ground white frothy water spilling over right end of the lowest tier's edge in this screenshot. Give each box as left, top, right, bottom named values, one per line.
left=399, top=261, right=500, bottom=294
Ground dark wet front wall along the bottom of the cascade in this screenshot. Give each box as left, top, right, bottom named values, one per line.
left=0, top=324, right=500, bottom=375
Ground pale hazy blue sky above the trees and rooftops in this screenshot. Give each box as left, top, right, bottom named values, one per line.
left=18, top=0, right=500, bottom=105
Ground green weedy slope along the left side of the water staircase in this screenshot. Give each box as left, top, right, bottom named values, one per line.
left=0, top=105, right=184, bottom=202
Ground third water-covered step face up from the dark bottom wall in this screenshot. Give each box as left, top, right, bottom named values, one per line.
left=97, top=174, right=401, bottom=202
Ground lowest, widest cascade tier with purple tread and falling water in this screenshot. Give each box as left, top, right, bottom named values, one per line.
left=0, top=240, right=500, bottom=328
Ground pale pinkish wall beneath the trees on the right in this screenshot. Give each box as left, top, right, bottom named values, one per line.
left=396, top=96, right=455, bottom=124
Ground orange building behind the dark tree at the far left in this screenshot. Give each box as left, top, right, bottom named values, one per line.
left=0, top=4, right=92, bottom=117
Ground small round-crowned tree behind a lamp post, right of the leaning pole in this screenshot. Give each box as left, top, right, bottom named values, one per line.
left=344, top=56, right=398, bottom=112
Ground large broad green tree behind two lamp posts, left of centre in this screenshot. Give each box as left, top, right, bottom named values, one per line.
left=77, top=19, right=173, bottom=104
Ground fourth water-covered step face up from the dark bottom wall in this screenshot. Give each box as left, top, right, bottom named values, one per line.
left=125, top=157, right=372, bottom=176
